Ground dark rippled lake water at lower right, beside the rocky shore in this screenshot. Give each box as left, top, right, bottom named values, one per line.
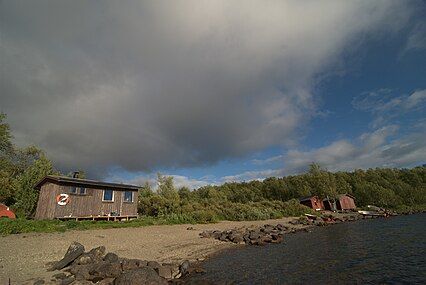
left=191, top=214, right=426, bottom=284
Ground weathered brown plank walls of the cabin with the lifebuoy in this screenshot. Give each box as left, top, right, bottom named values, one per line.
left=35, top=183, right=138, bottom=219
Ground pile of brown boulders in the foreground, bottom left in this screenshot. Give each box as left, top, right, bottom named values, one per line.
left=34, top=242, right=190, bottom=285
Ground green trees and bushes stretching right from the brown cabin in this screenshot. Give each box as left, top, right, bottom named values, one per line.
left=139, top=164, right=426, bottom=222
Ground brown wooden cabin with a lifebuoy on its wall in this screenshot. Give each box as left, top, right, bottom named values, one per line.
left=34, top=175, right=138, bottom=220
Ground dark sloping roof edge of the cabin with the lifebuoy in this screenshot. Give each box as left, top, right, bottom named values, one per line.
left=34, top=175, right=139, bottom=191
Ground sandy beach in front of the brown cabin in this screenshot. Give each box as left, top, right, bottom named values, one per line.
left=0, top=218, right=302, bottom=284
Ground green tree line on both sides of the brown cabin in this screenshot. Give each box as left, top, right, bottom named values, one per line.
left=0, top=114, right=426, bottom=219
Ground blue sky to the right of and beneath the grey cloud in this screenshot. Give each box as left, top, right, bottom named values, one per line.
left=118, top=7, right=426, bottom=187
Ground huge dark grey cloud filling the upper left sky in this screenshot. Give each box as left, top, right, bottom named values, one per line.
left=0, top=1, right=410, bottom=174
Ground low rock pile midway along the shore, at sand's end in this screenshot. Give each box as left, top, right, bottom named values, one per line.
left=200, top=224, right=295, bottom=245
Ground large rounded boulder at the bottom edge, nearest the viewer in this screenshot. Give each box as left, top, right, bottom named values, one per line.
left=114, top=266, right=168, bottom=285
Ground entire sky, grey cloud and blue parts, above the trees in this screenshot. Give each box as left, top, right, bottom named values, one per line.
left=0, top=0, right=426, bottom=189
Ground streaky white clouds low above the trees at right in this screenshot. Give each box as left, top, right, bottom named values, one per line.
left=222, top=123, right=426, bottom=182
